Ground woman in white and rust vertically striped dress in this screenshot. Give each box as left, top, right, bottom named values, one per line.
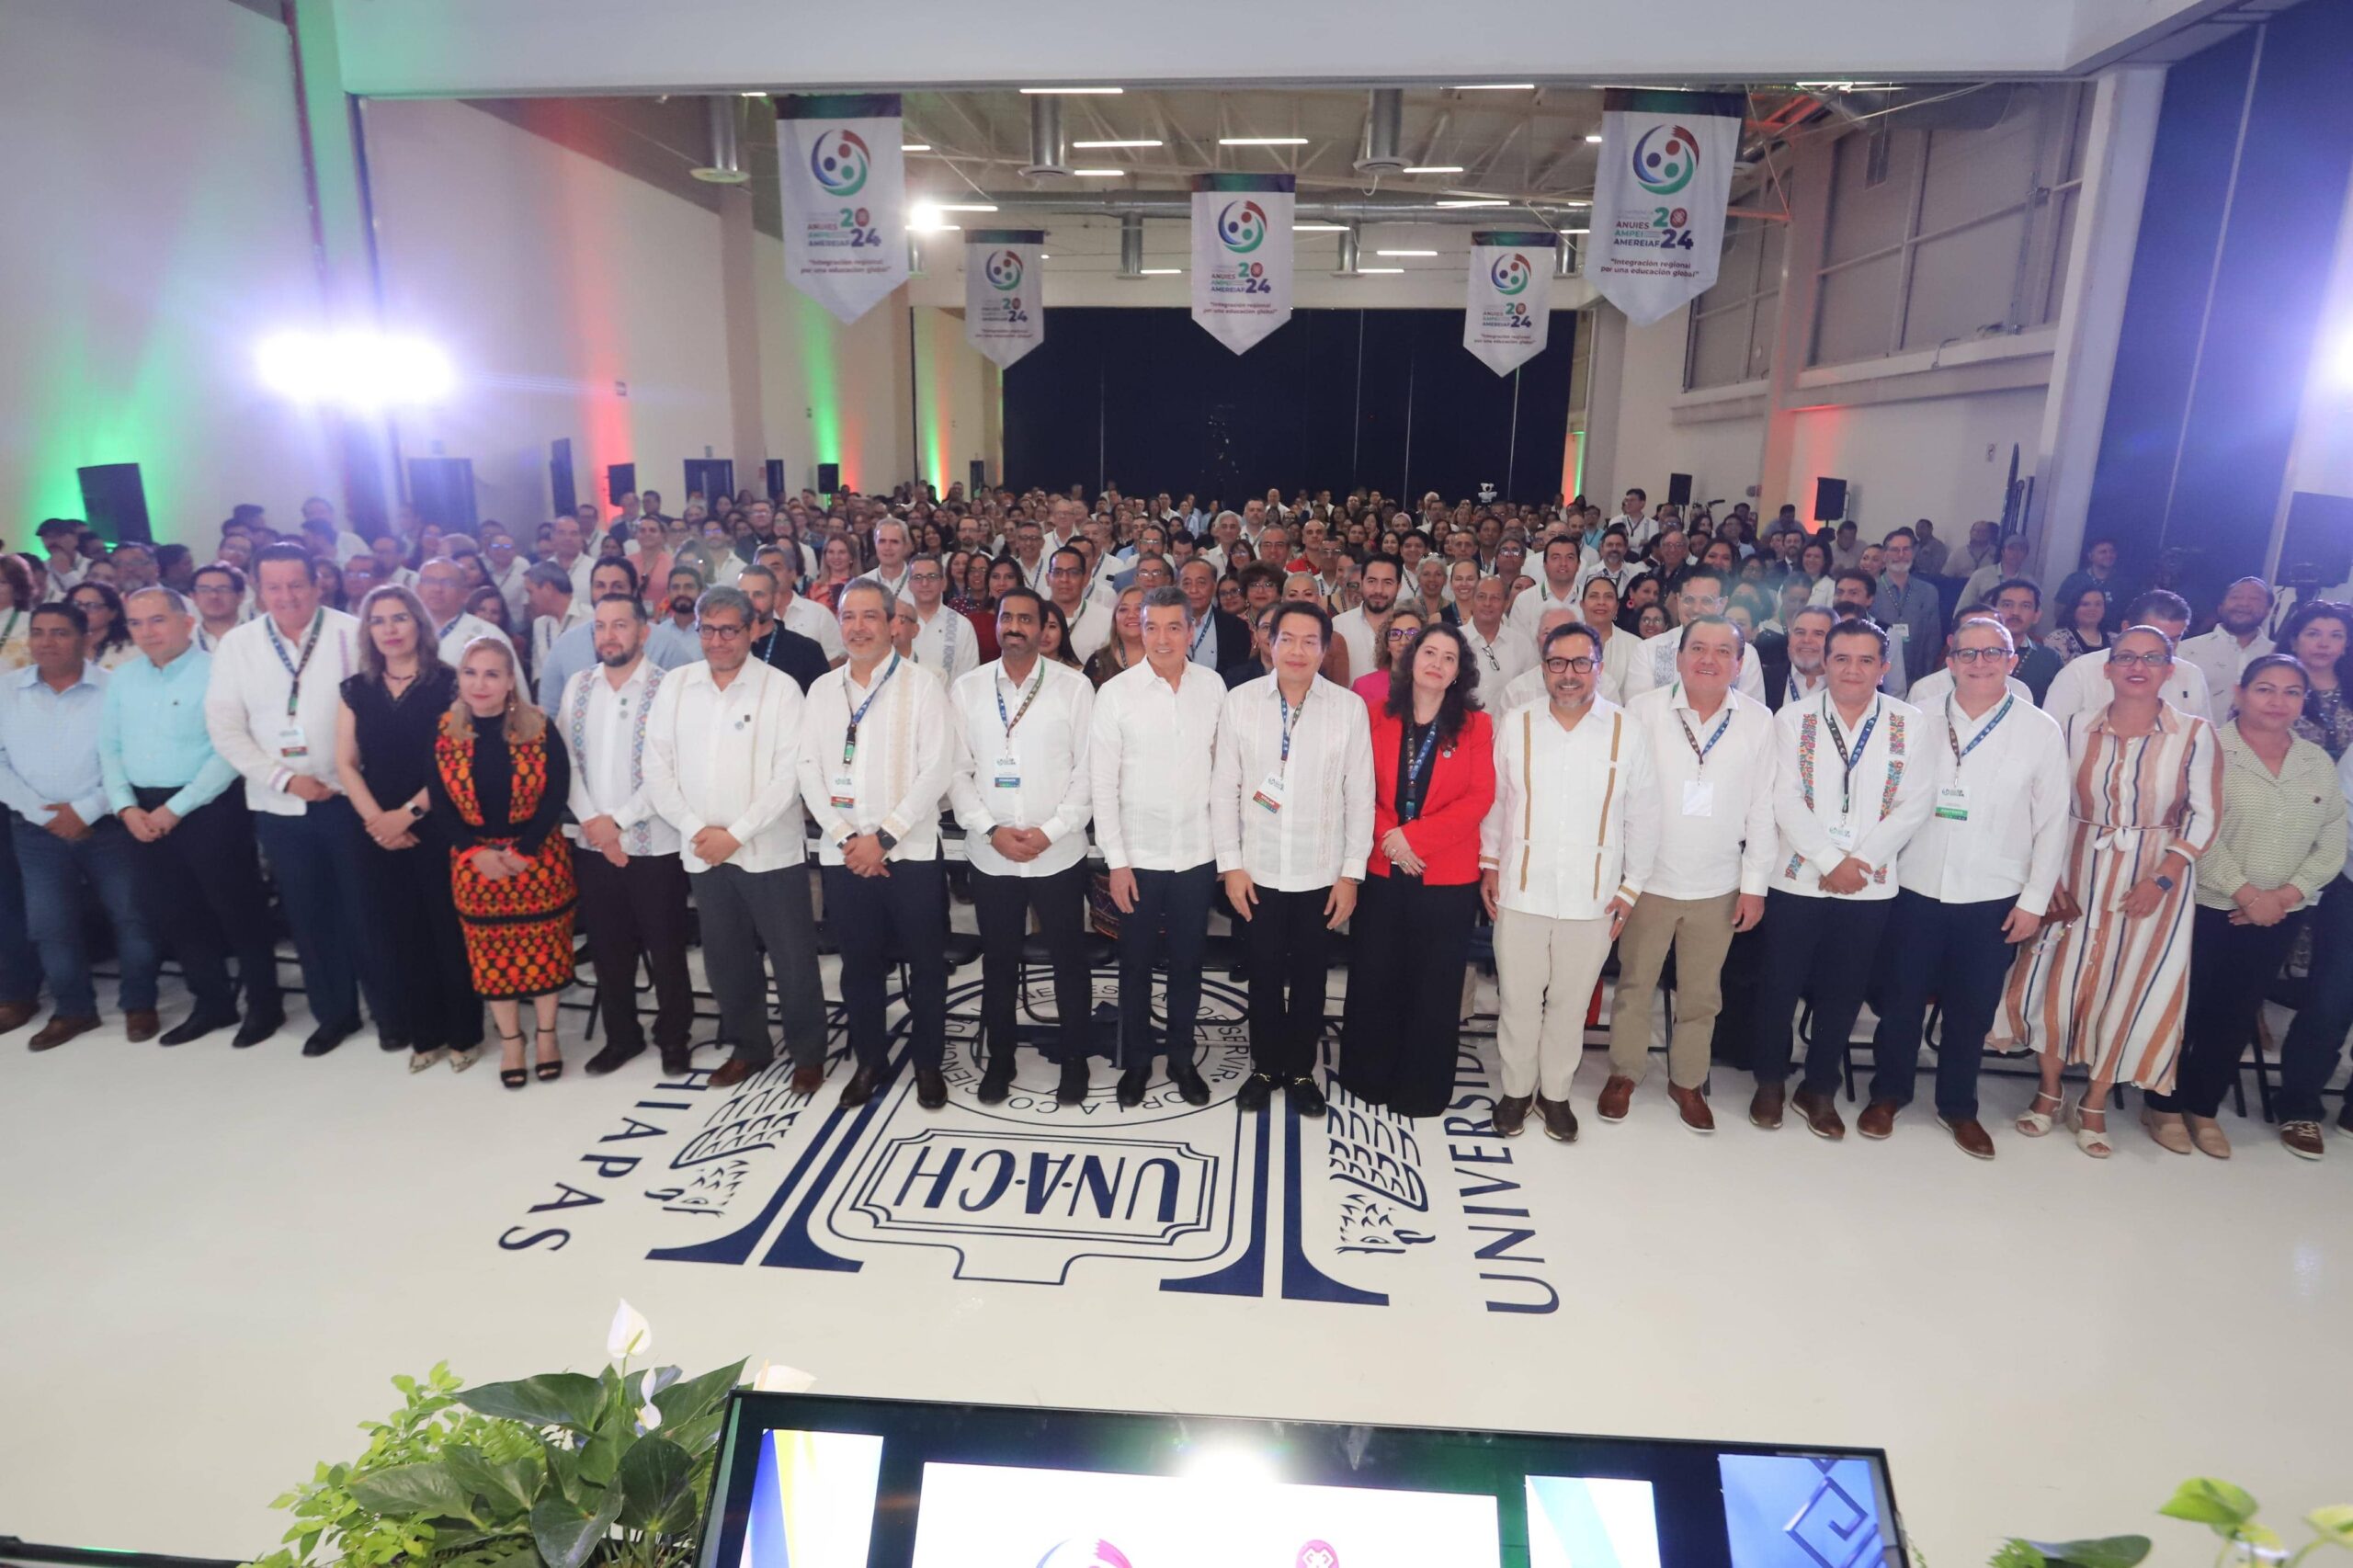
left=2003, top=626, right=2222, bottom=1158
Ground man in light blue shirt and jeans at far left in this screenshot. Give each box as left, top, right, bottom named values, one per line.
left=0, top=603, right=160, bottom=1050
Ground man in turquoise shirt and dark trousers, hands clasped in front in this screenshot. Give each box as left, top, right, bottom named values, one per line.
left=99, top=588, right=285, bottom=1045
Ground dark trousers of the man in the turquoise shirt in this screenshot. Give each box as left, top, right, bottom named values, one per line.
left=131, top=787, right=278, bottom=1017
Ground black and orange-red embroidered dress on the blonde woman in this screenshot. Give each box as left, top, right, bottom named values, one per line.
left=428, top=713, right=576, bottom=1001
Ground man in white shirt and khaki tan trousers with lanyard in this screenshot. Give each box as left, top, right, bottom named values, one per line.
left=1597, top=615, right=1774, bottom=1132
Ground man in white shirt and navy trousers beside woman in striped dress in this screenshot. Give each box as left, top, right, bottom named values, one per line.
left=1854, top=615, right=2071, bottom=1161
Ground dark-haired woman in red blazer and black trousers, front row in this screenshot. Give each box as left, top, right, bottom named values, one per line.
left=1339, top=621, right=1495, bottom=1116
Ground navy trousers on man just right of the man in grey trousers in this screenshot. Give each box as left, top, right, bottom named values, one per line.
left=824, top=859, right=949, bottom=1072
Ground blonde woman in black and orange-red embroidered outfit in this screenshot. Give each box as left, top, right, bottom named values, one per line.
left=428, top=638, right=574, bottom=1087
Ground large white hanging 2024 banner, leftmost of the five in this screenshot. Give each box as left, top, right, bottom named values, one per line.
left=777, top=94, right=906, bottom=323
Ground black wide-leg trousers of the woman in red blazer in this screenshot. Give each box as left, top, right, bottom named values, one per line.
left=1339, top=873, right=1478, bottom=1116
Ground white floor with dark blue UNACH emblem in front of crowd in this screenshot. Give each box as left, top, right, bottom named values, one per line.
left=0, top=972, right=2353, bottom=1568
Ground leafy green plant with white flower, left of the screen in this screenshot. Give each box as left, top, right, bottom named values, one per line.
left=254, top=1302, right=744, bottom=1568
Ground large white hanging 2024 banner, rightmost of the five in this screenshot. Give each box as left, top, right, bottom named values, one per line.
left=1586, top=87, right=1748, bottom=327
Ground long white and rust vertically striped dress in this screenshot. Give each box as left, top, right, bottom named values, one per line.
left=1988, top=704, right=2222, bottom=1093
